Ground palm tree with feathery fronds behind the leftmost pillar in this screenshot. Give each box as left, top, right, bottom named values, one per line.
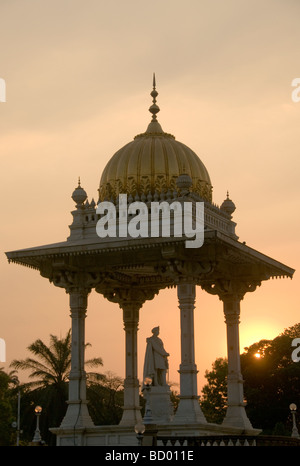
left=11, top=330, right=104, bottom=444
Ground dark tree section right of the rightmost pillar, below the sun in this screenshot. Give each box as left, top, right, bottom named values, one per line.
left=241, top=324, right=300, bottom=433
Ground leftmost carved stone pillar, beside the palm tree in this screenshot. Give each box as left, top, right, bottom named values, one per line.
left=61, top=288, right=93, bottom=429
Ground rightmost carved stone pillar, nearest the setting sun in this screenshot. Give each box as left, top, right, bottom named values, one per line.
left=221, top=294, right=252, bottom=429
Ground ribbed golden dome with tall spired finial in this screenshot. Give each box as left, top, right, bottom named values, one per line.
left=99, top=77, right=212, bottom=202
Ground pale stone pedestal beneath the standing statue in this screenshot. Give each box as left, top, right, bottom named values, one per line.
left=143, top=385, right=174, bottom=424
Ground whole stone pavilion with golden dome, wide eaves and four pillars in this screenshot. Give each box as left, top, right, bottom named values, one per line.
left=6, top=79, right=294, bottom=445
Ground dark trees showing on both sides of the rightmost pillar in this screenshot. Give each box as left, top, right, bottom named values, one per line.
left=200, top=324, right=300, bottom=435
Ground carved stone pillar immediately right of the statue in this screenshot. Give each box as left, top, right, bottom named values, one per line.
left=174, top=284, right=206, bottom=424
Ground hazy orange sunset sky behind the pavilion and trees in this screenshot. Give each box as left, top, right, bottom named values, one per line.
left=0, top=0, right=300, bottom=391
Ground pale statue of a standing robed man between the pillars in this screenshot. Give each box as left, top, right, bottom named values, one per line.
left=144, top=327, right=169, bottom=386
